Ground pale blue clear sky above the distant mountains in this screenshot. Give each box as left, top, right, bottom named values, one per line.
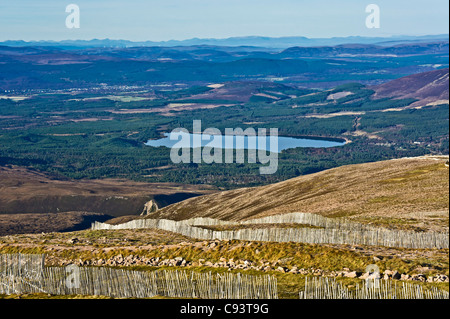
left=0, top=0, right=449, bottom=41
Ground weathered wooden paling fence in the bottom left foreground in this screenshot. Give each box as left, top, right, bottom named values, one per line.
left=0, top=254, right=278, bottom=299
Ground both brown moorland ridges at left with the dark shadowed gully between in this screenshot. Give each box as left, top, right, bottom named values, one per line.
left=0, top=166, right=216, bottom=236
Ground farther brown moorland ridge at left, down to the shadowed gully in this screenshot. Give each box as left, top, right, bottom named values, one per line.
left=0, top=167, right=211, bottom=216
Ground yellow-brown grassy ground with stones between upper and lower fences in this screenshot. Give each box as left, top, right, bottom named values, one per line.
left=0, top=229, right=448, bottom=299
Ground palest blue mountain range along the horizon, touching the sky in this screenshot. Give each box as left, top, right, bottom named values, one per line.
left=0, top=34, right=449, bottom=49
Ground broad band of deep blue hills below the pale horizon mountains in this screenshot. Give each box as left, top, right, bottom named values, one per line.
left=0, top=39, right=449, bottom=90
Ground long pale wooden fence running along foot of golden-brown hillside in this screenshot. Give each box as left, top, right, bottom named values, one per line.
left=91, top=213, right=449, bottom=249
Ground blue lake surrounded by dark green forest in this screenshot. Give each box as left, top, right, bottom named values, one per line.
left=145, top=132, right=346, bottom=153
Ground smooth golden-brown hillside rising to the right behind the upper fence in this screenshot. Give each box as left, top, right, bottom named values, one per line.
left=150, top=156, right=449, bottom=227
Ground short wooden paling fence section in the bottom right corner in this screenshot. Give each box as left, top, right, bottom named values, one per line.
left=299, top=277, right=449, bottom=299
